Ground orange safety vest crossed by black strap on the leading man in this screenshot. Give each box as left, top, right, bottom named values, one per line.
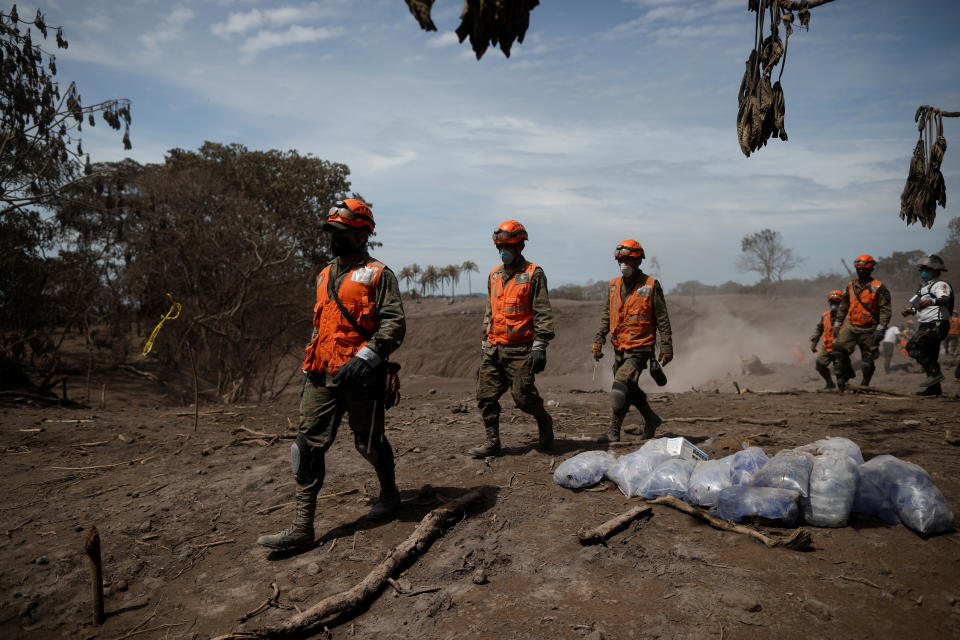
left=303, top=258, right=385, bottom=373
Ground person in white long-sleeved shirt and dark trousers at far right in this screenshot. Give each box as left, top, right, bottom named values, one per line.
left=901, top=255, right=954, bottom=396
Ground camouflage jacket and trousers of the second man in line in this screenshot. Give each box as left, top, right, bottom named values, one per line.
left=477, top=258, right=554, bottom=426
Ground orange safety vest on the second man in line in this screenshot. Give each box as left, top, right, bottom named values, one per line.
left=487, top=262, right=537, bottom=344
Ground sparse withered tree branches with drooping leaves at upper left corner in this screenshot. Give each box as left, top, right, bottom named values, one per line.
left=0, top=5, right=130, bottom=213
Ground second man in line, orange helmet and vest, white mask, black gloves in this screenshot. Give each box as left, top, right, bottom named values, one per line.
left=467, top=220, right=554, bottom=458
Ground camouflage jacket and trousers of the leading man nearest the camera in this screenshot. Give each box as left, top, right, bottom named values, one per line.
left=298, top=255, right=406, bottom=480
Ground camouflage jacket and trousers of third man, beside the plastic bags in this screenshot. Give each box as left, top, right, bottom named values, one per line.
left=593, top=270, right=673, bottom=428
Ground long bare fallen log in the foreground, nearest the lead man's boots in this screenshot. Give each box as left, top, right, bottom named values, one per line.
left=214, top=490, right=483, bottom=640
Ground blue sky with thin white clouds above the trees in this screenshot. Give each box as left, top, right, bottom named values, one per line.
left=28, top=0, right=960, bottom=288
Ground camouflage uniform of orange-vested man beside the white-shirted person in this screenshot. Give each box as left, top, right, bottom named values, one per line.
left=832, top=278, right=893, bottom=385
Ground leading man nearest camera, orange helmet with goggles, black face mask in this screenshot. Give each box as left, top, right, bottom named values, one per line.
left=257, top=198, right=406, bottom=551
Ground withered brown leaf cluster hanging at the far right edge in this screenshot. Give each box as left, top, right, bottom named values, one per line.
left=900, top=104, right=960, bottom=227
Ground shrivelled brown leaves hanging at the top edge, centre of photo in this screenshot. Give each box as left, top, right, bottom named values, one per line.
left=406, top=0, right=540, bottom=60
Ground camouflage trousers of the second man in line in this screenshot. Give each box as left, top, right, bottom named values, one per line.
left=477, top=343, right=543, bottom=424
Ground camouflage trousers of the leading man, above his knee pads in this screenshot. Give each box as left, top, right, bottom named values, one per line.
left=298, top=373, right=393, bottom=476
